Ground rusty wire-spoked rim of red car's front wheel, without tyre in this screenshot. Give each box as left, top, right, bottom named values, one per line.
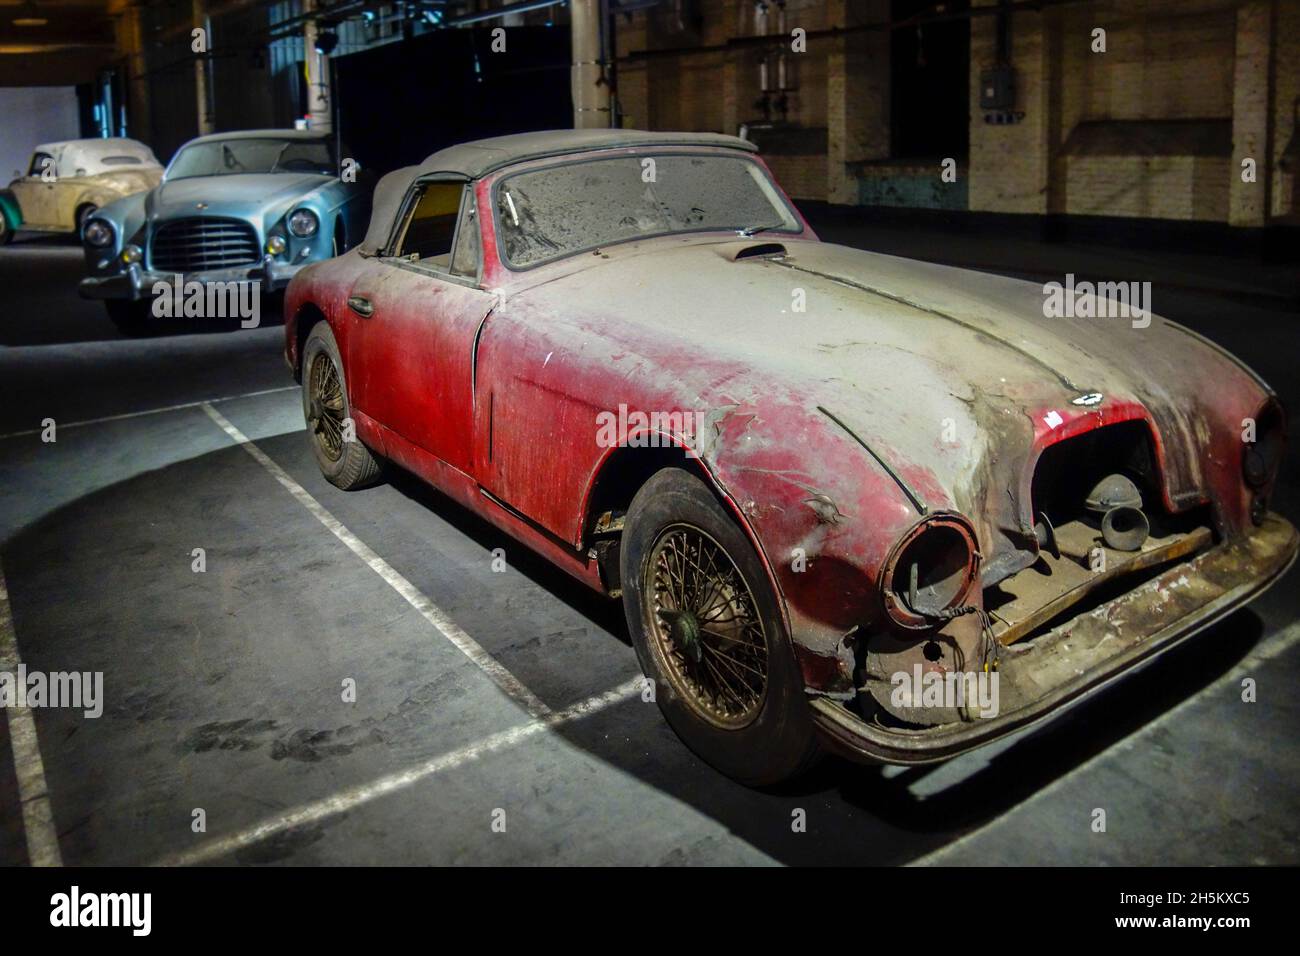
left=644, top=524, right=768, bottom=730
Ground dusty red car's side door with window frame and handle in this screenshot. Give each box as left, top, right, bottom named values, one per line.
left=347, top=179, right=495, bottom=473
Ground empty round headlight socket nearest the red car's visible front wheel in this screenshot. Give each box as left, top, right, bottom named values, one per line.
left=880, top=514, right=978, bottom=628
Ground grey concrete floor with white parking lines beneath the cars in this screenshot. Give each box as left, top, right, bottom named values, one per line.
left=0, top=230, right=1300, bottom=865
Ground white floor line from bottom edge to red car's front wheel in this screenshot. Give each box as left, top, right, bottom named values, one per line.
left=153, top=678, right=645, bottom=866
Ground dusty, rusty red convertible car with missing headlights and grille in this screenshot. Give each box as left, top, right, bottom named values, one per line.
left=285, top=130, right=1297, bottom=784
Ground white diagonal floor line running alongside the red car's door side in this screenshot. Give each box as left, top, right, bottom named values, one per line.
left=203, top=402, right=551, bottom=718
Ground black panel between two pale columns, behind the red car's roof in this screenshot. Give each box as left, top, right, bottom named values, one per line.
left=333, top=26, right=573, bottom=173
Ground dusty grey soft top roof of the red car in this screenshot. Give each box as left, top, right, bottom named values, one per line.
left=361, top=130, right=758, bottom=252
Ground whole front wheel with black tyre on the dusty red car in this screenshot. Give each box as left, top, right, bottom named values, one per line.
left=620, top=468, right=819, bottom=786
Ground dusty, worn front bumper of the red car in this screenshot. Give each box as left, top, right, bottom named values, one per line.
left=811, top=514, right=1300, bottom=765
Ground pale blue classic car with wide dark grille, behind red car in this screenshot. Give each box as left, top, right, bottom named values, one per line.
left=81, top=130, right=369, bottom=330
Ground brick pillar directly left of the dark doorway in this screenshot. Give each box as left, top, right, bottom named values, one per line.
left=826, top=0, right=891, bottom=206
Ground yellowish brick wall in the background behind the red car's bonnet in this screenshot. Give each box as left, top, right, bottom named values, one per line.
left=619, top=0, right=1300, bottom=225
